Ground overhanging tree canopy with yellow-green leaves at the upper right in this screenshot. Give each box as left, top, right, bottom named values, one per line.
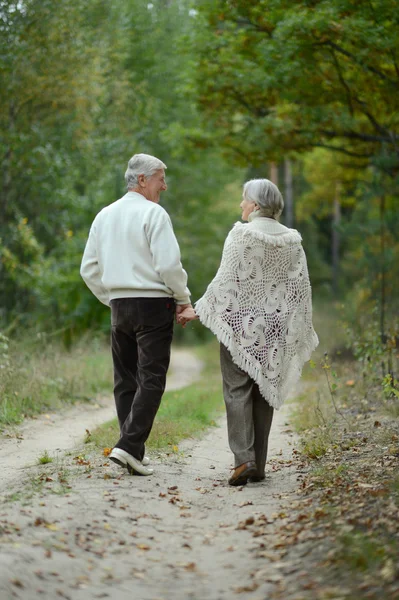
left=198, top=0, right=399, bottom=175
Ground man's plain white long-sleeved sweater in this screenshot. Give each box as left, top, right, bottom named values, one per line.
left=80, top=192, right=190, bottom=305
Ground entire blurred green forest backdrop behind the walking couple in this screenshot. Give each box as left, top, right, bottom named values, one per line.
left=0, top=0, right=399, bottom=423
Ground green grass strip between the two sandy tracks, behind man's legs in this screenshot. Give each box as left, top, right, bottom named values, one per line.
left=90, top=342, right=223, bottom=451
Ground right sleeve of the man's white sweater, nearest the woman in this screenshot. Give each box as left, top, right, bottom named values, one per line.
left=147, top=212, right=190, bottom=304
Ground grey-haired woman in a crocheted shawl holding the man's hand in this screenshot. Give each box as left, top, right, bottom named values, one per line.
left=179, top=179, right=318, bottom=485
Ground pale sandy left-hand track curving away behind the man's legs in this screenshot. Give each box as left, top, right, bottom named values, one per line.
left=0, top=349, right=202, bottom=496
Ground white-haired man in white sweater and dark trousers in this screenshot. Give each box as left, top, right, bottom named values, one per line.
left=80, top=154, right=191, bottom=475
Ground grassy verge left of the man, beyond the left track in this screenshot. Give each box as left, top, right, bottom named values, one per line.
left=0, top=338, right=112, bottom=431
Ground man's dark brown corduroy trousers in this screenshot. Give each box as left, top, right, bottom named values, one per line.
left=111, top=298, right=175, bottom=461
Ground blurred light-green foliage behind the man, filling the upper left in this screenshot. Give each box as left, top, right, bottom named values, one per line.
left=0, top=0, right=240, bottom=338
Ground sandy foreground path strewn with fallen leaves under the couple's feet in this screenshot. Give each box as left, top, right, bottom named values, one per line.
left=0, top=350, right=298, bottom=600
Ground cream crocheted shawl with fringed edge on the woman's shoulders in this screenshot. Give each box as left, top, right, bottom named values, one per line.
left=195, top=217, right=318, bottom=409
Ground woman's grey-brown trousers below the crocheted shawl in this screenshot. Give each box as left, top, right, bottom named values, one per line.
left=220, top=344, right=273, bottom=476
